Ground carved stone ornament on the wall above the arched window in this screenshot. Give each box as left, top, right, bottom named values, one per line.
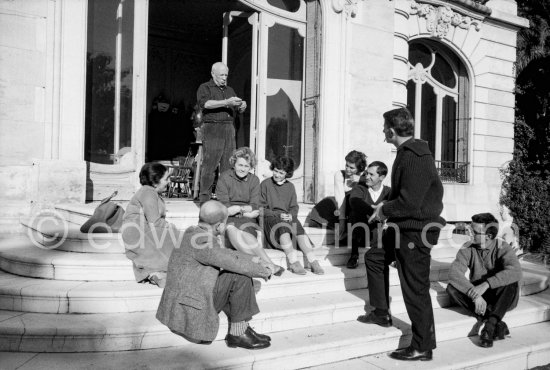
left=410, top=0, right=481, bottom=38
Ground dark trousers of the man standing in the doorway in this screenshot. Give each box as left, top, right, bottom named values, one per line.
left=203, top=122, right=236, bottom=203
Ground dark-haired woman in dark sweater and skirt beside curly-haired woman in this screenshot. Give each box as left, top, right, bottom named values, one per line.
left=260, top=156, right=325, bottom=275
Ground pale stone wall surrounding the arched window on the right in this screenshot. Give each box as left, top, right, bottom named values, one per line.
left=326, top=0, right=528, bottom=221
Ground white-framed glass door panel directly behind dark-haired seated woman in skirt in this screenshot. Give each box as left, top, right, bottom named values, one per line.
left=257, top=14, right=305, bottom=179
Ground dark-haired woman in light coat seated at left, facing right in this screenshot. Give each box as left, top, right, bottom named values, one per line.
left=122, top=162, right=180, bottom=288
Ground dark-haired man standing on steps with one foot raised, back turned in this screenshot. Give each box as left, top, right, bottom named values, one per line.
left=358, top=108, right=445, bottom=361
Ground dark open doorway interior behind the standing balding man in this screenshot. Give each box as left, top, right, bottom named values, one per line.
left=146, top=0, right=252, bottom=161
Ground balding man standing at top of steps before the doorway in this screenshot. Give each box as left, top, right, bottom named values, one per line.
left=197, top=62, right=246, bottom=204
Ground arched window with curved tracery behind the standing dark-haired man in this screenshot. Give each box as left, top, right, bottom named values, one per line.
left=407, top=40, right=470, bottom=182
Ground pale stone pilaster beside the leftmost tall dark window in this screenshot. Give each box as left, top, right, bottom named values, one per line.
left=29, top=0, right=87, bottom=212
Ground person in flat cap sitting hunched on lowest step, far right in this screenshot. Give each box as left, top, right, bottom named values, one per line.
left=447, top=213, right=521, bottom=348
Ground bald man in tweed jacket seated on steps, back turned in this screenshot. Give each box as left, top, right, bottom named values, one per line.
left=157, top=200, right=271, bottom=349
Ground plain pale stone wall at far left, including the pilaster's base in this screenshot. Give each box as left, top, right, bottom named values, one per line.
left=0, top=0, right=86, bottom=232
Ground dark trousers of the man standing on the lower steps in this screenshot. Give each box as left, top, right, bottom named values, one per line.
left=365, top=224, right=439, bottom=351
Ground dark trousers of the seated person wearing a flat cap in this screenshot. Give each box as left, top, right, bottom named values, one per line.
left=447, top=283, right=519, bottom=321
